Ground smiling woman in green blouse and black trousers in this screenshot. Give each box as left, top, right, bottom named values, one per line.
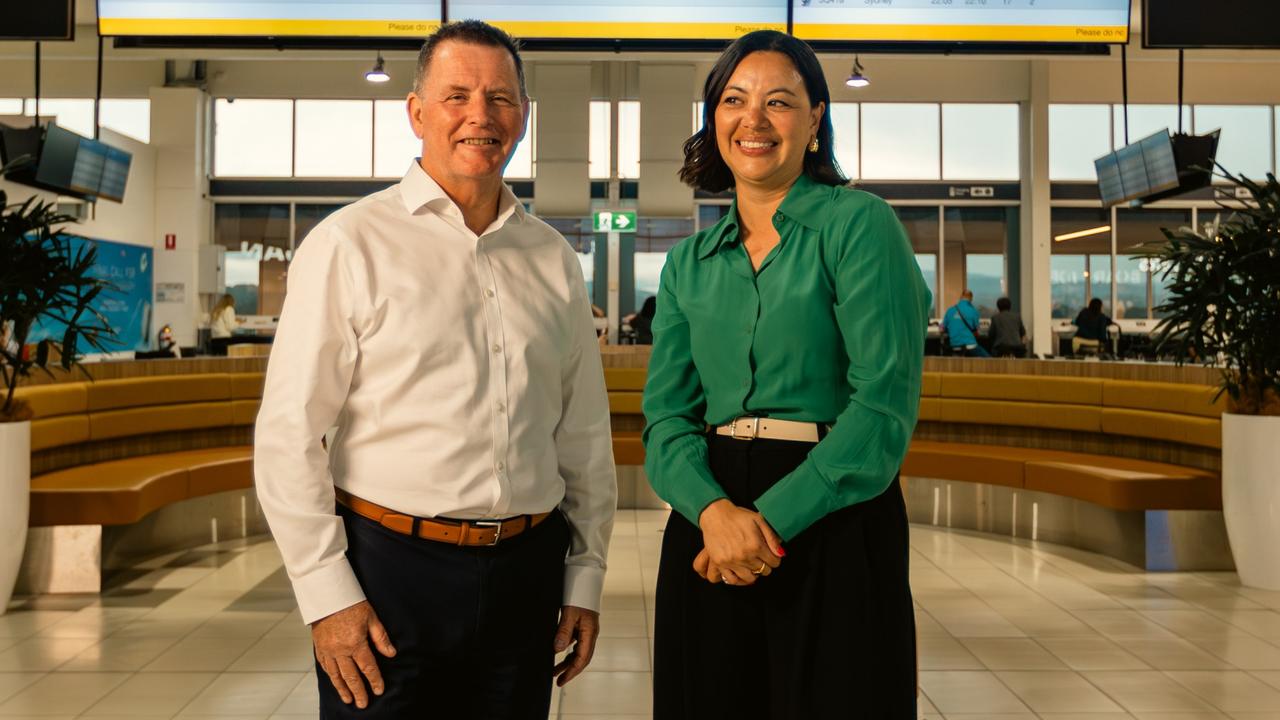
left=644, top=31, right=929, bottom=720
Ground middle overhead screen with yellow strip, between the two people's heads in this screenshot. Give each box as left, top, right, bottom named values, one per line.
left=448, top=0, right=787, bottom=40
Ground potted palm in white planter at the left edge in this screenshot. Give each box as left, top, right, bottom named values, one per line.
left=0, top=183, right=114, bottom=615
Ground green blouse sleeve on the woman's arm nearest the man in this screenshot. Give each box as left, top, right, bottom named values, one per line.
left=644, top=255, right=727, bottom=525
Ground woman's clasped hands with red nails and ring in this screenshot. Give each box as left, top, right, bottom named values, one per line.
left=694, top=498, right=786, bottom=585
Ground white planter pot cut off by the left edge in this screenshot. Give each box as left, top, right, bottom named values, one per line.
left=0, top=423, right=31, bottom=615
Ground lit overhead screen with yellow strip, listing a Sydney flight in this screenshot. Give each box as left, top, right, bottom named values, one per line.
left=791, top=0, right=1129, bottom=45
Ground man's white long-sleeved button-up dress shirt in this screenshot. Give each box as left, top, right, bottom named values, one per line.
left=253, top=163, right=617, bottom=623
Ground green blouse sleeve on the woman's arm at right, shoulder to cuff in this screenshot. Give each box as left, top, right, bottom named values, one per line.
left=755, top=200, right=929, bottom=539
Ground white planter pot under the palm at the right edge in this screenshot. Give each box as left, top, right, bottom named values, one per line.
left=1222, top=413, right=1280, bottom=591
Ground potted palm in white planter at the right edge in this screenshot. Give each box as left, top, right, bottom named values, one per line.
left=1139, top=173, right=1280, bottom=591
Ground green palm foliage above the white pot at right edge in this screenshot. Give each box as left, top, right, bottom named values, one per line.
left=1137, top=173, right=1280, bottom=415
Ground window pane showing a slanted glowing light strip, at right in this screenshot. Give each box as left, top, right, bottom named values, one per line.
left=1050, top=208, right=1111, bottom=320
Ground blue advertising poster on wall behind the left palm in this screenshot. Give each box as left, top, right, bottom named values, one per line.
left=28, top=237, right=155, bottom=352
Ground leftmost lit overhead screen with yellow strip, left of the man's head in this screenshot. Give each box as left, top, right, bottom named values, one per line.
left=97, top=0, right=442, bottom=37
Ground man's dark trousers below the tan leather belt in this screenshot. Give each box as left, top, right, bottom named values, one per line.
left=316, top=506, right=568, bottom=720
